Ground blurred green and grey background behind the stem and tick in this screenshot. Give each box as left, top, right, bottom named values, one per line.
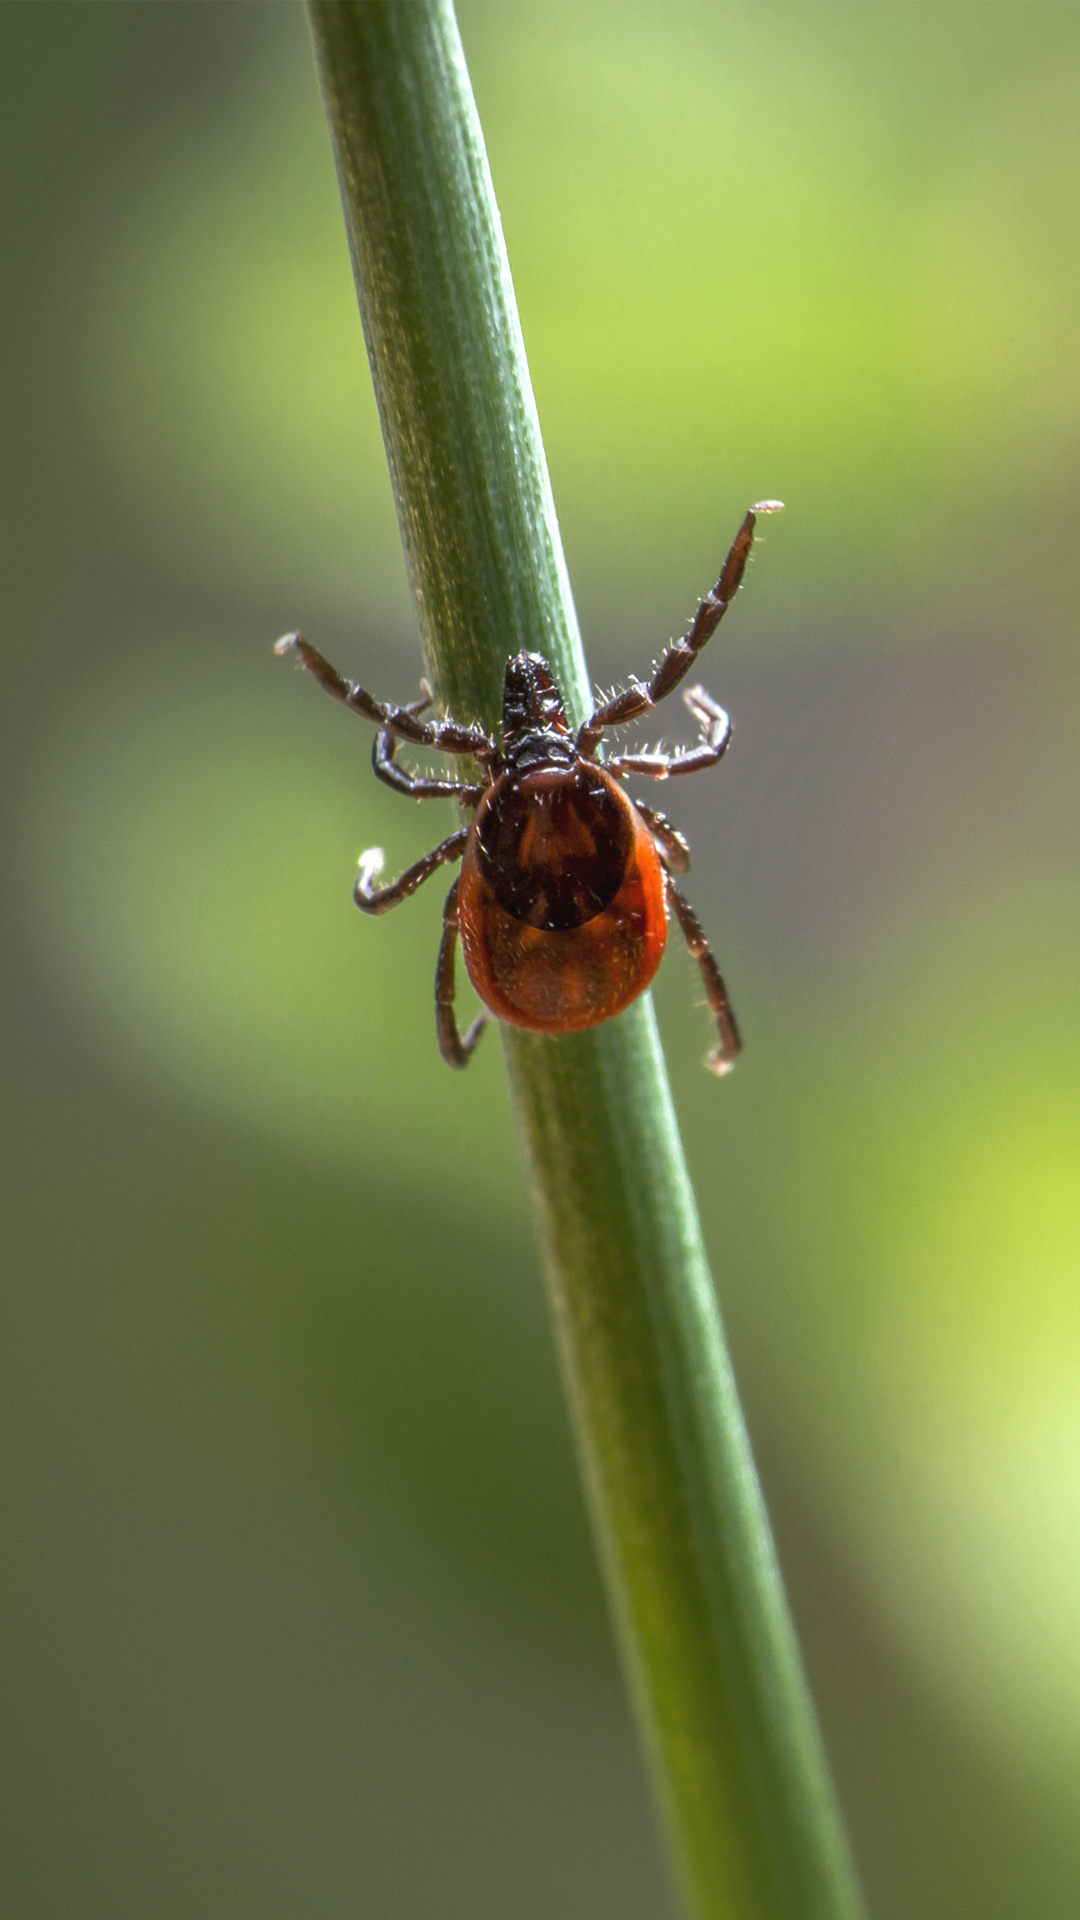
left=0, top=0, right=1080, bottom=1920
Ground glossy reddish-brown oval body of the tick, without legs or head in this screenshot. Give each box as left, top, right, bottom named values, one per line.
left=457, top=762, right=667, bottom=1033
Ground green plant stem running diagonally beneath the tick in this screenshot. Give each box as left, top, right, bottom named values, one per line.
left=299, top=0, right=861, bottom=1920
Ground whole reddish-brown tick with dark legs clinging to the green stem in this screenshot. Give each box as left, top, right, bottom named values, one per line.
left=277, top=499, right=782, bottom=1073
